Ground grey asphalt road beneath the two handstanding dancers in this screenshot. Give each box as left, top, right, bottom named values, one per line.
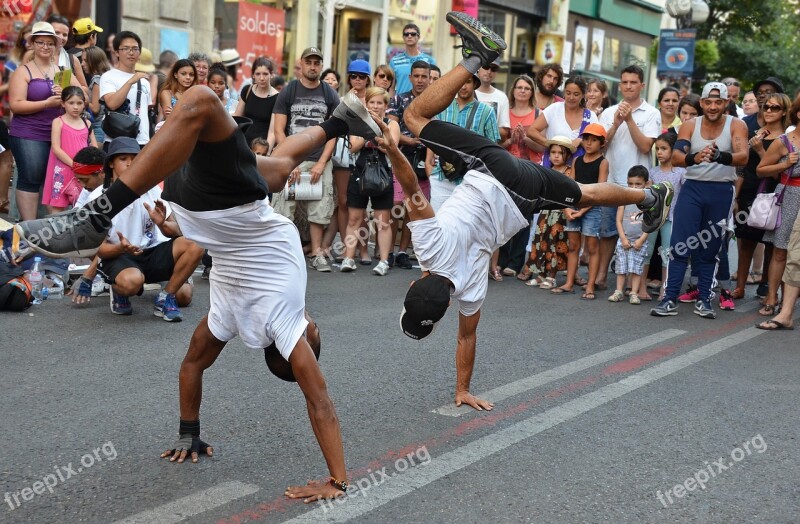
left=0, top=261, right=800, bottom=523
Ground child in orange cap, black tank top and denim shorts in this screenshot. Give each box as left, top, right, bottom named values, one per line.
left=550, top=124, right=608, bottom=300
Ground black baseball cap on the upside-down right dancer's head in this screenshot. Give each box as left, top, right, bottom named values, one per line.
left=400, top=274, right=450, bottom=340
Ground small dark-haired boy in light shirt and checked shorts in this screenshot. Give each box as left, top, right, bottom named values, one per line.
left=608, top=166, right=650, bottom=304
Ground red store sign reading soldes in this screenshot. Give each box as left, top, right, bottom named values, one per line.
left=236, top=1, right=286, bottom=78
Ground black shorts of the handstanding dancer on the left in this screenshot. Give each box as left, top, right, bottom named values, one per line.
left=163, top=129, right=269, bottom=211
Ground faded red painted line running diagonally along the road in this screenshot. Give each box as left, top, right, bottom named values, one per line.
left=217, top=313, right=756, bottom=524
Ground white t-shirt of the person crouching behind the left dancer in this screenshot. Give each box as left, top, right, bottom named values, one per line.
left=89, top=186, right=172, bottom=249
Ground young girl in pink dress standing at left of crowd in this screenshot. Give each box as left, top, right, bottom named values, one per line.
left=42, top=86, right=97, bottom=214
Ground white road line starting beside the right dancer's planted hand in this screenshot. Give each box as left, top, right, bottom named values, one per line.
left=433, top=329, right=686, bottom=417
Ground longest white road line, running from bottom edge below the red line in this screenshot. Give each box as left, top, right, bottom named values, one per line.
left=284, top=328, right=764, bottom=524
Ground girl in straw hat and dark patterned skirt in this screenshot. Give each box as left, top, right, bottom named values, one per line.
left=525, top=136, right=576, bottom=289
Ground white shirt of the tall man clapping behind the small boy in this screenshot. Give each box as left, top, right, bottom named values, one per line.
left=600, top=99, right=661, bottom=187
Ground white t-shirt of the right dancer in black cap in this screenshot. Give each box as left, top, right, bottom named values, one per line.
left=408, top=170, right=528, bottom=316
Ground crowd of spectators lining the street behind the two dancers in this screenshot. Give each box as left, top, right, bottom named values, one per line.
left=0, top=16, right=800, bottom=327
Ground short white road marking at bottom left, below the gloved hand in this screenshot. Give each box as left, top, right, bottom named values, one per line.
left=114, top=481, right=259, bottom=524
